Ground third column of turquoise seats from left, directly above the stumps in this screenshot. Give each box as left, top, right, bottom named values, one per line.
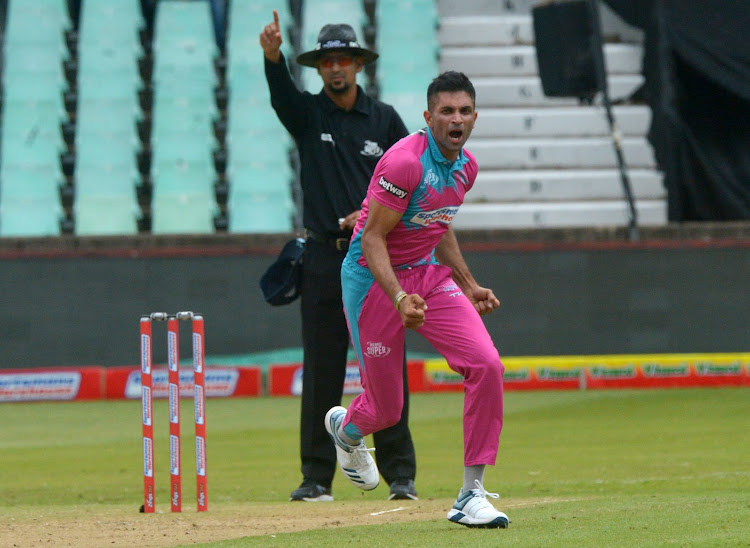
left=151, top=1, right=217, bottom=233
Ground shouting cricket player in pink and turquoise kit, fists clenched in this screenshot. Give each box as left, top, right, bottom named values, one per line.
left=325, top=72, right=509, bottom=528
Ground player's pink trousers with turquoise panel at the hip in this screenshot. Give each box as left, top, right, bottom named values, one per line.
left=341, top=257, right=504, bottom=466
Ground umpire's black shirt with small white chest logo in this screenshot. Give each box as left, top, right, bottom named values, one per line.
left=264, top=54, right=408, bottom=235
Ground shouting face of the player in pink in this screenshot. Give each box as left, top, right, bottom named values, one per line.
left=424, top=91, right=477, bottom=162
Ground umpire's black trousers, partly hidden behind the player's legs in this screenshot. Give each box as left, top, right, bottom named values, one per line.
left=300, top=238, right=417, bottom=486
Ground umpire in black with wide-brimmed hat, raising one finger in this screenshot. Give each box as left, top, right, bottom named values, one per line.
left=260, top=10, right=417, bottom=501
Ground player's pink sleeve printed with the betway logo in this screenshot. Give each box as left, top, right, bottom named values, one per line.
left=367, top=149, right=422, bottom=212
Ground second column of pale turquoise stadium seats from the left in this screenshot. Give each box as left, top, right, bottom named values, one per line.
left=73, top=2, right=143, bottom=235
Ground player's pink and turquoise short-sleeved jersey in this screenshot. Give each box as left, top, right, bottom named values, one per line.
left=349, top=128, right=478, bottom=267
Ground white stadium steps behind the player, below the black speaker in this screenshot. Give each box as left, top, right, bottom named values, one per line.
left=437, top=0, right=666, bottom=229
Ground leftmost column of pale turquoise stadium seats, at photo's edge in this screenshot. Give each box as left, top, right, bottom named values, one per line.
left=0, top=0, right=70, bottom=236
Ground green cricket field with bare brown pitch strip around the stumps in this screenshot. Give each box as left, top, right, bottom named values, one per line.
left=0, top=388, right=750, bottom=547
